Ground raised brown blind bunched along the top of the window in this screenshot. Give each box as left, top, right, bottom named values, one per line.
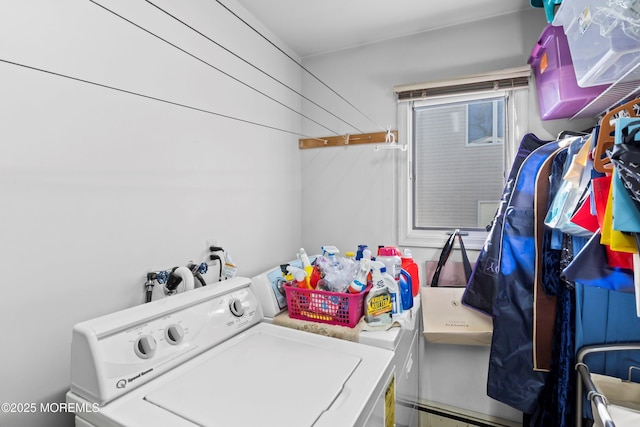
left=393, top=65, right=531, bottom=101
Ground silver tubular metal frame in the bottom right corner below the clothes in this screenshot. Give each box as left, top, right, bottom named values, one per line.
left=575, top=343, right=640, bottom=427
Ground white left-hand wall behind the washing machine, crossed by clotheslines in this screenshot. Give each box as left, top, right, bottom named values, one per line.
left=0, top=0, right=301, bottom=427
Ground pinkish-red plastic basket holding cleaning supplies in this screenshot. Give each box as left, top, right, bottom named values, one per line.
left=284, top=285, right=369, bottom=328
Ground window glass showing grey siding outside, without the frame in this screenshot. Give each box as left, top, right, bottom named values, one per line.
left=411, top=94, right=505, bottom=230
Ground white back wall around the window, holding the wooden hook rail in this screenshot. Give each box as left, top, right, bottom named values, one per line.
left=302, top=9, right=593, bottom=420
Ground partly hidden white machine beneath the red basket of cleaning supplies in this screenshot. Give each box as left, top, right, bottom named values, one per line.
left=251, top=259, right=421, bottom=427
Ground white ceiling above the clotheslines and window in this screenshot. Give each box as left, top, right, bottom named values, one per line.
left=237, top=0, right=544, bottom=57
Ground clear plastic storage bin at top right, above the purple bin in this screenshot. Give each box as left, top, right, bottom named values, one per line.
left=553, top=0, right=640, bottom=87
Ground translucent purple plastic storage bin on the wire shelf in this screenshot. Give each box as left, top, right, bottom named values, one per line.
left=528, top=25, right=609, bottom=120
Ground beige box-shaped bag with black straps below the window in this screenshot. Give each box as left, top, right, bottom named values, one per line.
left=420, top=230, right=493, bottom=346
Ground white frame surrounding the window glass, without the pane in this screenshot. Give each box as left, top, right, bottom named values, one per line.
left=396, top=87, right=528, bottom=250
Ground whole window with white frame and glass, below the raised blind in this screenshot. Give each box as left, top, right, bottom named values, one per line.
left=398, top=68, right=528, bottom=249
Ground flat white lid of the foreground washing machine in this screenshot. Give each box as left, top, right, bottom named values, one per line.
left=145, top=333, right=360, bottom=427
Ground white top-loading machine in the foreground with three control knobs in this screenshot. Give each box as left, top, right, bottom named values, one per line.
left=67, top=278, right=395, bottom=427
